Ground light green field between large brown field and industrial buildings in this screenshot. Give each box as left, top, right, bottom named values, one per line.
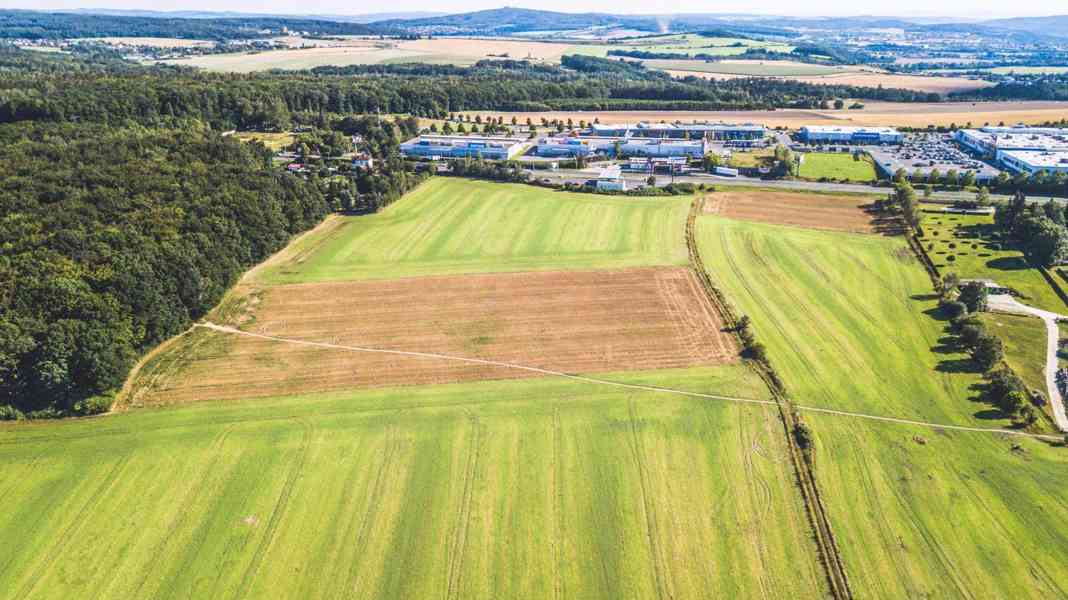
left=249, top=177, right=690, bottom=283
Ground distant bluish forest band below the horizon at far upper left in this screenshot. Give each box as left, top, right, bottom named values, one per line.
left=0, top=11, right=387, bottom=41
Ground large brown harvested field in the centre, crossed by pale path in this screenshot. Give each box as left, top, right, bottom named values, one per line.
left=142, top=267, right=738, bottom=404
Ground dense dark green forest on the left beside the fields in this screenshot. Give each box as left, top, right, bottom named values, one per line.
left=0, top=124, right=333, bottom=419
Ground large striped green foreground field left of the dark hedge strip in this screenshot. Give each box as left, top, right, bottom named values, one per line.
left=0, top=365, right=826, bottom=599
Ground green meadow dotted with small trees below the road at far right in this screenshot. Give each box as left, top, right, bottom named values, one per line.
left=920, top=212, right=1068, bottom=313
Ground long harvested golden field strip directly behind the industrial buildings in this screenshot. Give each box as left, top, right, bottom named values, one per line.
left=459, top=100, right=1068, bottom=127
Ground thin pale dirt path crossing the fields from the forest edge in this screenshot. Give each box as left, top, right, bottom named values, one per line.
left=193, top=322, right=1064, bottom=442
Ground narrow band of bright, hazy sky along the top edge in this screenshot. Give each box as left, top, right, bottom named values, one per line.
left=10, top=0, right=1068, bottom=18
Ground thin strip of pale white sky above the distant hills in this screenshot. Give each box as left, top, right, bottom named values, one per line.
left=8, top=0, right=1068, bottom=20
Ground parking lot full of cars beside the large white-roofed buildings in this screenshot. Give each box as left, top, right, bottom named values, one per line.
left=865, top=133, right=1000, bottom=181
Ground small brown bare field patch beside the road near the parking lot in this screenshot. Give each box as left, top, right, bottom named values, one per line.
left=704, top=191, right=901, bottom=235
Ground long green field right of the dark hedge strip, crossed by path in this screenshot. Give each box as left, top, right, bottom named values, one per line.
left=698, top=217, right=1068, bottom=599
